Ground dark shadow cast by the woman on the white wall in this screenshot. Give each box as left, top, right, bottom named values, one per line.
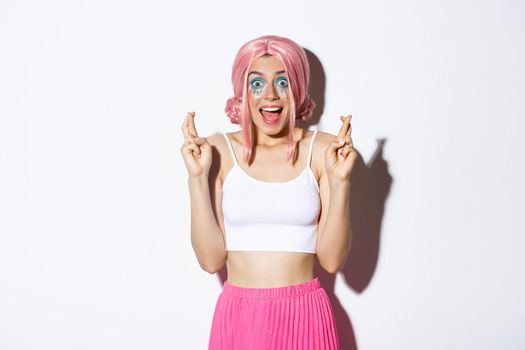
left=218, top=49, right=392, bottom=350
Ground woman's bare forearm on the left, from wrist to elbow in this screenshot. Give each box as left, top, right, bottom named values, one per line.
left=188, top=177, right=226, bottom=273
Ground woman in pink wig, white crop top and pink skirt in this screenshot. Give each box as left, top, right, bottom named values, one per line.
left=181, top=35, right=357, bottom=350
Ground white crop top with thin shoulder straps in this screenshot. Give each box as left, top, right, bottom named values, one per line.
left=222, top=131, right=321, bottom=254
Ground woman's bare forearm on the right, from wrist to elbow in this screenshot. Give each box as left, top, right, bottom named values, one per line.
left=317, top=182, right=352, bottom=273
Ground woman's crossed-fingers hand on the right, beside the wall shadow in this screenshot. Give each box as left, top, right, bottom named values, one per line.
left=325, top=115, right=357, bottom=183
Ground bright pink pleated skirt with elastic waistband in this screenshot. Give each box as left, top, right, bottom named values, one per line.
left=208, top=277, right=339, bottom=350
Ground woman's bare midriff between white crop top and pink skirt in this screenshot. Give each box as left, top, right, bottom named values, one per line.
left=226, top=251, right=315, bottom=288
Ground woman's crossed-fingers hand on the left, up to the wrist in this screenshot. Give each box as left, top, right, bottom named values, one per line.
left=180, top=112, right=212, bottom=177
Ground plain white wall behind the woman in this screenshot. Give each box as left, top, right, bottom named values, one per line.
left=0, top=0, right=525, bottom=350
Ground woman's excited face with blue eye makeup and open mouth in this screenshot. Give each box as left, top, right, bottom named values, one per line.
left=248, top=55, right=290, bottom=135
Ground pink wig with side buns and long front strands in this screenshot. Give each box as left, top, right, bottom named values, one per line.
left=225, top=35, right=315, bottom=163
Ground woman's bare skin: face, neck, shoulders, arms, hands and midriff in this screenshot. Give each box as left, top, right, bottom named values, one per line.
left=181, top=56, right=357, bottom=288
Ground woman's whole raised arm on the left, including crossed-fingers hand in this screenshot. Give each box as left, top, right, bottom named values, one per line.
left=181, top=113, right=227, bottom=273
